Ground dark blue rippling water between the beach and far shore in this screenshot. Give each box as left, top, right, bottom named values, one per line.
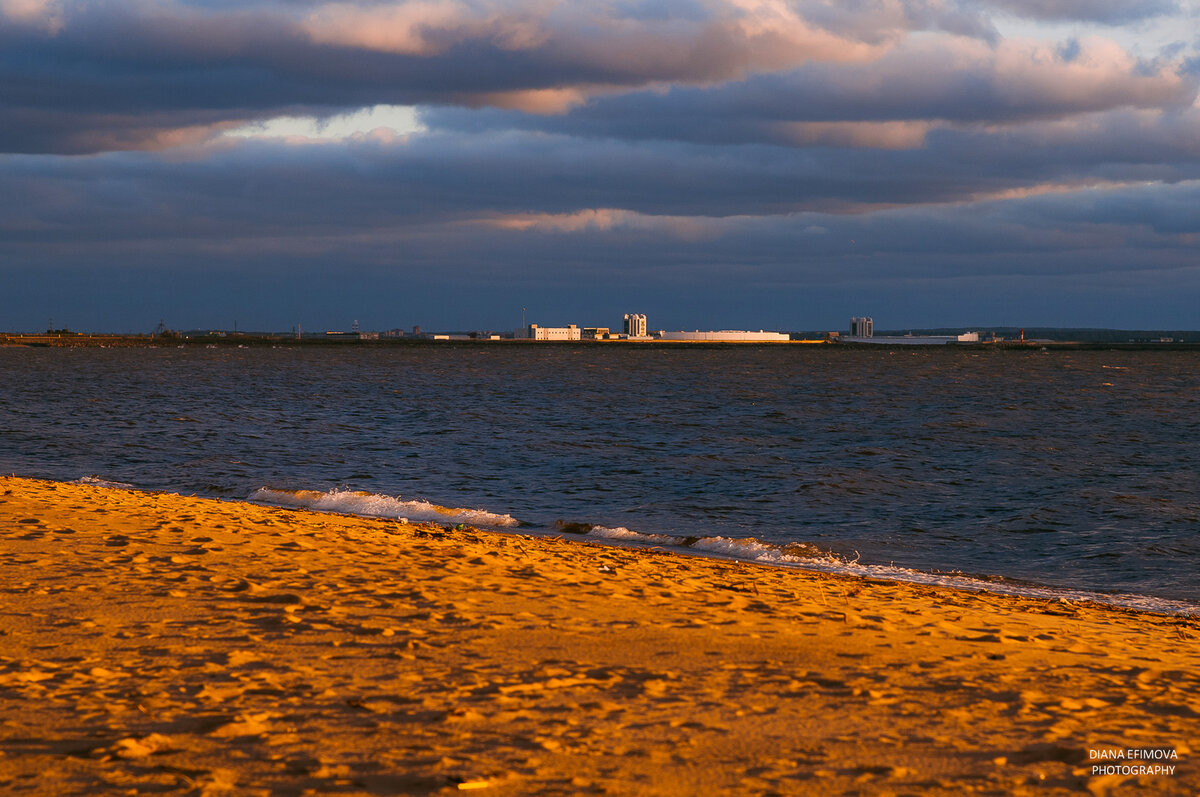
left=0, top=344, right=1200, bottom=601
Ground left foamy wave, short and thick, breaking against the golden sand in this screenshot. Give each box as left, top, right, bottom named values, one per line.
left=248, top=487, right=521, bottom=527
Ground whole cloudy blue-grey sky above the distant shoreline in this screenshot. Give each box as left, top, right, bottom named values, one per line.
left=0, top=0, right=1200, bottom=332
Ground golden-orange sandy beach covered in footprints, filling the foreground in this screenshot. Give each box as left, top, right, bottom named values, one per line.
left=0, top=478, right=1200, bottom=795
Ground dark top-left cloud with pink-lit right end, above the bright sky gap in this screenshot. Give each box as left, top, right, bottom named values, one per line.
left=0, top=0, right=931, bottom=152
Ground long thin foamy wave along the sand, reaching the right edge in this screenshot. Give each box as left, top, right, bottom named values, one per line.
left=558, top=523, right=1200, bottom=615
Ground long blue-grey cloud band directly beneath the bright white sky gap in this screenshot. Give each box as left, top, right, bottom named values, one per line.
left=0, top=114, right=1200, bottom=252
